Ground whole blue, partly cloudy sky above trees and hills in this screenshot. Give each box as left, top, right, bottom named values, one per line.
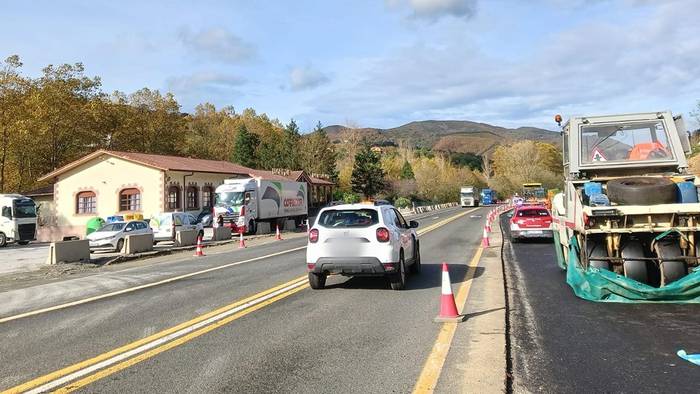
left=0, top=0, right=700, bottom=130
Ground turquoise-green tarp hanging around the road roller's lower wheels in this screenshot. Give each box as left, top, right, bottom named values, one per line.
left=554, top=232, right=700, bottom=304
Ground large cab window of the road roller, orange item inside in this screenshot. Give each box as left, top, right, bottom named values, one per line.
left=581, top=121, right=673, bottom=163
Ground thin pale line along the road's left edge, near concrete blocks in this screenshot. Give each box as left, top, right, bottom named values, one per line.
left=0, top=246, right=306, bottom=323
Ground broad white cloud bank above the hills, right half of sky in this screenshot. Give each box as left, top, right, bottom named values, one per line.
left=311, top=1, right=700, bottom=127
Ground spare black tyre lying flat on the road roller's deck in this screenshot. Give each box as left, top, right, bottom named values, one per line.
left=608, top=177, right=676, bottom=205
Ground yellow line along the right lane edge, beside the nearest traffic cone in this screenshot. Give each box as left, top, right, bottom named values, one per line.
left=413, top=247, right=484, bottom=394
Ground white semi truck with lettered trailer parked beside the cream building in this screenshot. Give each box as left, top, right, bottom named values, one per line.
left=214, top=178, right=309, bottom=234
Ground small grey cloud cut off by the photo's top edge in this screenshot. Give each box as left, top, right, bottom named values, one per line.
left=385, top=0, right=477, bottom=21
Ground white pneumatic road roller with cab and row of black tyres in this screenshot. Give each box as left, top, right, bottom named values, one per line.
left=552, top=111, right=700, bottom=296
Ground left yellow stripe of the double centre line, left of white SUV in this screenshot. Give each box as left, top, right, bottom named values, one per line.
left=3, top=275, right=306, bottom=394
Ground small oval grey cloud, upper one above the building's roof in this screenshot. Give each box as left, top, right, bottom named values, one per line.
left=179, top=28, right=256, bottom=63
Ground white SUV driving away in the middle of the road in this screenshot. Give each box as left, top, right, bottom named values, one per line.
left=306, top=202, right=420, bottom=290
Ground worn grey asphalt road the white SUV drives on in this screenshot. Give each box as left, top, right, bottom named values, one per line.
left=0, top=208, right=484, bottom=392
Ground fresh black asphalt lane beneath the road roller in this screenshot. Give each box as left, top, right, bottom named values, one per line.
left=502, top=215, right=700, bottom=393
